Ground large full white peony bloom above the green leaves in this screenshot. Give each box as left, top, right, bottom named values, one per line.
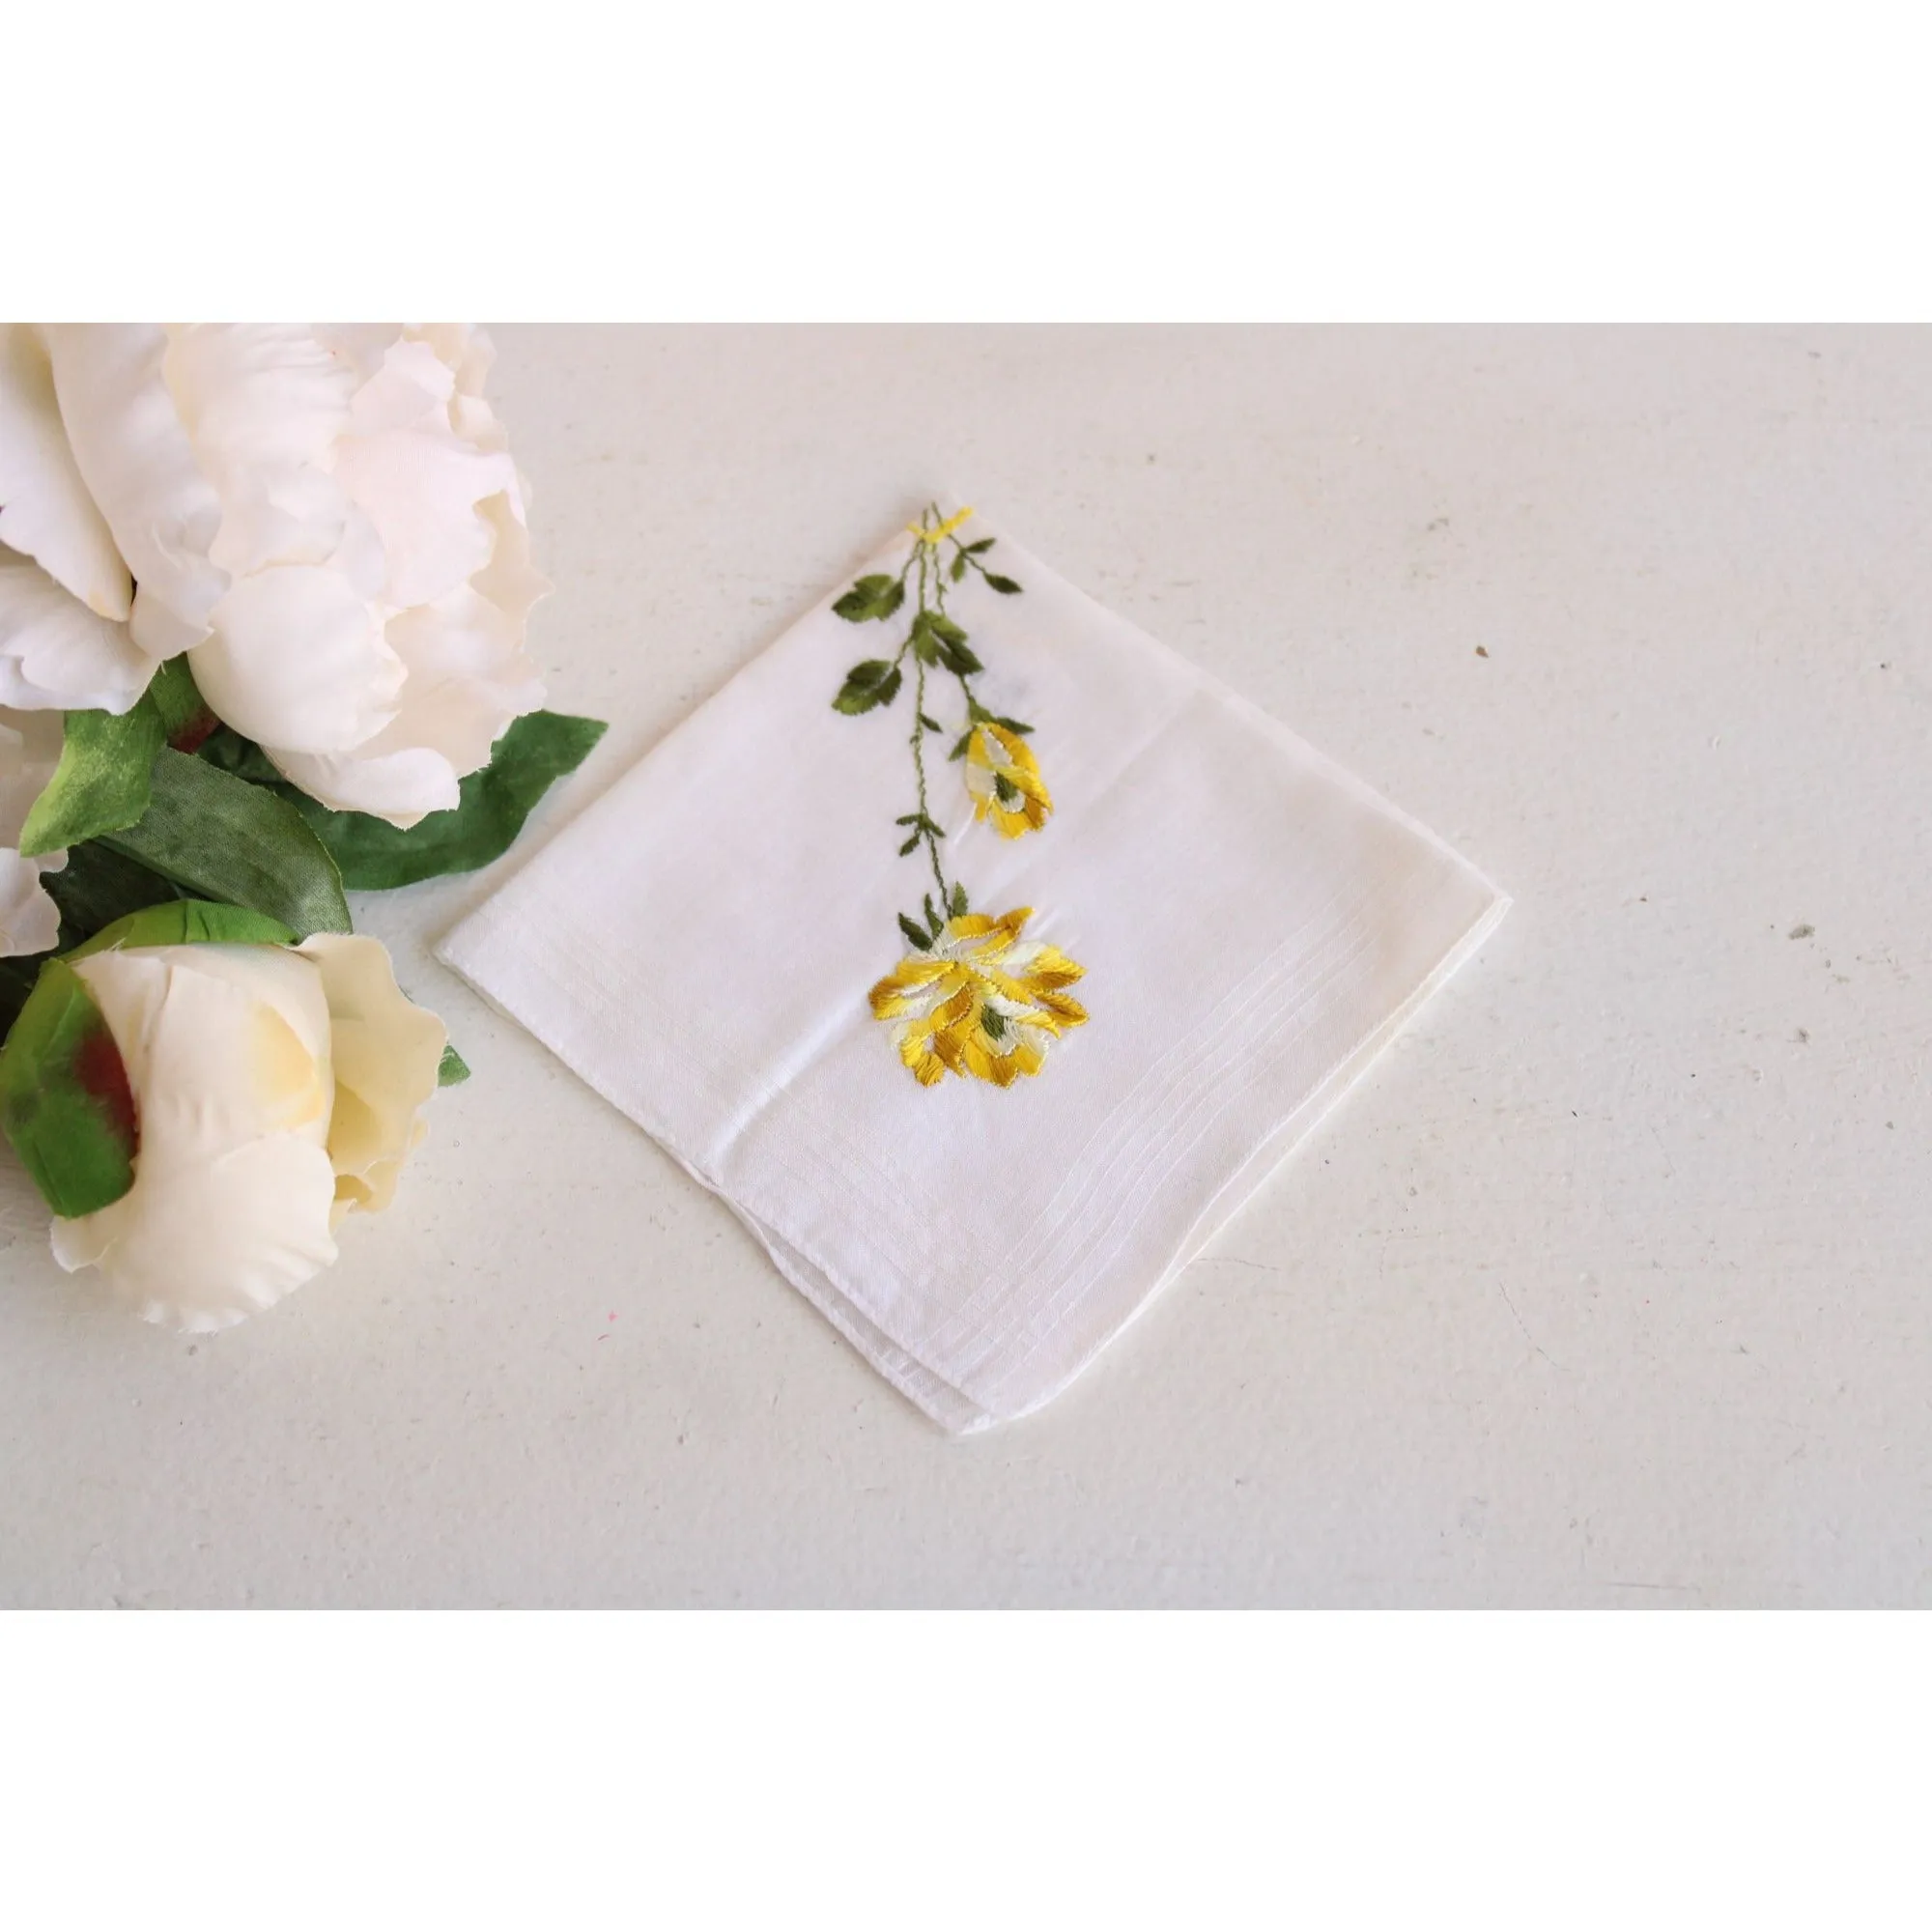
left=0, top=325, right=549, bottom=827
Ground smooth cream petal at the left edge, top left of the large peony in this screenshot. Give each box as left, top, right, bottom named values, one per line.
left=0, top=323, right=133, bottom=624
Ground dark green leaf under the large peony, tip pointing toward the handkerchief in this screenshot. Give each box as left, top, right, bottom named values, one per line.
left=261, top=711, right=605, bottom=893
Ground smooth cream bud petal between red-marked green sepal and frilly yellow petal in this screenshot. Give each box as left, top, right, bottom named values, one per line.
left=54, top=945, right=336, bottom=1333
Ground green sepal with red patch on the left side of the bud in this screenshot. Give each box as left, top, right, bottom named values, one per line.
left=0, top=958, right=137, bottom=1219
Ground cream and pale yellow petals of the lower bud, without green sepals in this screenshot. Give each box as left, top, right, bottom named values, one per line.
left=54, top=933, right=444, bottom=1331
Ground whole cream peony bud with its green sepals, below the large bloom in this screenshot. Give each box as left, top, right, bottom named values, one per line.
left=0, top=902, right=446, bottom=1331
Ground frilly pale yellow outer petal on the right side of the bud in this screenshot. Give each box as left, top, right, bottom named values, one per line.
left=298, top=933, right=448, bottom=1221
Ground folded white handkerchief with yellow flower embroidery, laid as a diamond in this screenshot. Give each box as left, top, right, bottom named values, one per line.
left=442, top=510, right=1507, bottom=1430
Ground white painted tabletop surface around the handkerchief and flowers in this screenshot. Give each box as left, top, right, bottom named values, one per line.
left=0, top=328, right=1932, bottom=1607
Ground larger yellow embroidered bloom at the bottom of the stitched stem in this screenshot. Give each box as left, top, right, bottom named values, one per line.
left=871, top=906, right=1086, bottom=1088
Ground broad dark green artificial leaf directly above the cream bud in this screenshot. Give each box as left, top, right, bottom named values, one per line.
left=108, top=746, right=352, bottom=939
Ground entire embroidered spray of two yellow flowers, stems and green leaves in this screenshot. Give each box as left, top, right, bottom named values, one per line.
left=833, top=504, right=1086, bottom=1088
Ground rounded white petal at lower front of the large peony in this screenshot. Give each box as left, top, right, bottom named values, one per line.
left=189, top=564, right=408, bottom=752
